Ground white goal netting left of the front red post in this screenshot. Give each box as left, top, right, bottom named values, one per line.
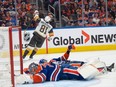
left=0, top=27, right=11, bottom=87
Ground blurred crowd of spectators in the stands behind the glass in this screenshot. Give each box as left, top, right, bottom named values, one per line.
left=0, top=0, right=116, bottom=29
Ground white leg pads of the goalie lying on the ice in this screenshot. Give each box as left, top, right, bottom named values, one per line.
left=77, top=60, right=107, bottom=80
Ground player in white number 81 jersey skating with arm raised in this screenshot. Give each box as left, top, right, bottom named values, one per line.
left=23, top=10, right=54, bottom=59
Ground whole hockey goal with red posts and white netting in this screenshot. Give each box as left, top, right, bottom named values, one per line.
left=0, top=27, right=23, bottom=87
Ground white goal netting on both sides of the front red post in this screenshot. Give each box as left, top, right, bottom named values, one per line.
left=0, top=27, right=20, bottom=87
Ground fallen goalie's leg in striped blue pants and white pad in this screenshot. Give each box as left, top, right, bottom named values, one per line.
left=63, top=61, right=103, bottom=80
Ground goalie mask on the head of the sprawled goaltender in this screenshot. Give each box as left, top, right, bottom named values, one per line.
left=28, top=62, right=42, bottom=75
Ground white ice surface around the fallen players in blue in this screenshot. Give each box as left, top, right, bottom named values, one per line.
left=0, top=50, right=116, bottom=87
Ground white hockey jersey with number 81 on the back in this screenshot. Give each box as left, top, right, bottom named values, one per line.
left=35, top=19, right=53, bottom=38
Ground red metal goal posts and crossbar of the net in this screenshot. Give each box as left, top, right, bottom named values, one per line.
left=9, top=27, right=23, bottom=87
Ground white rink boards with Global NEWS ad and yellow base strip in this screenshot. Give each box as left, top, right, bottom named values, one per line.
left=0, top=26, right=116, bottom=55
